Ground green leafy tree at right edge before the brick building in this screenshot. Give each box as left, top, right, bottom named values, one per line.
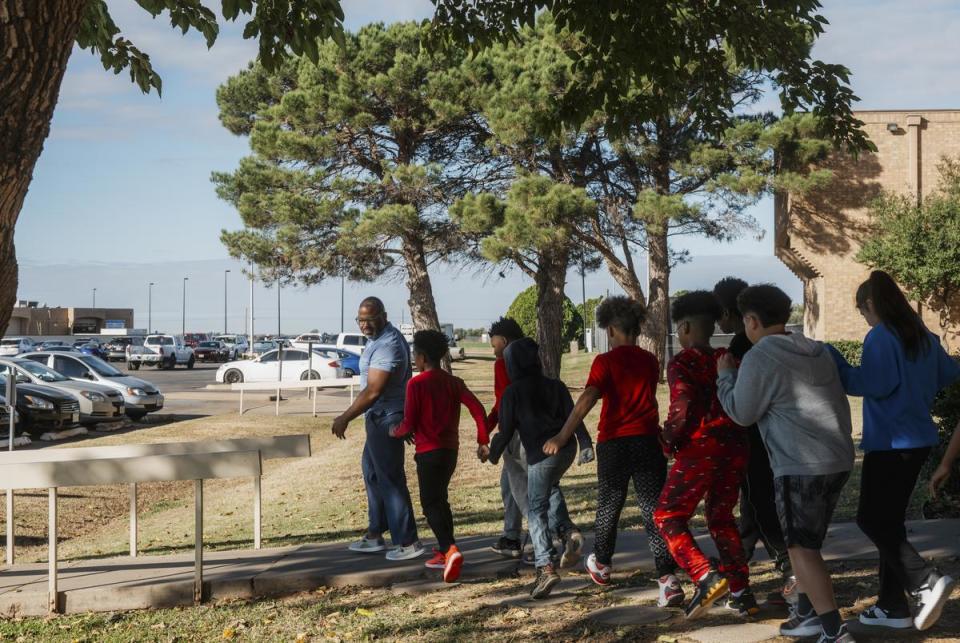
left=857, top=159, right=960, bottom=332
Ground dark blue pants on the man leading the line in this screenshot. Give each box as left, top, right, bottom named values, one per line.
left=360, top=411, right=417, bottom=545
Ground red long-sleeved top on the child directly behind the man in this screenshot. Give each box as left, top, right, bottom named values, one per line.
left=397, top=368, right=490, bottom=453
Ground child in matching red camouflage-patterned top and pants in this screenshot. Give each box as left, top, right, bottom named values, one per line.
left=654, top=290, right=759, bottom=619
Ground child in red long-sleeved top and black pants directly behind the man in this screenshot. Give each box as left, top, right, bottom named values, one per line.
left=390, top=330, right=490, bottom=583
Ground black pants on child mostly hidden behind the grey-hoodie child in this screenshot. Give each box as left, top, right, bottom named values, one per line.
left=740, top=425, right=790, bottom=573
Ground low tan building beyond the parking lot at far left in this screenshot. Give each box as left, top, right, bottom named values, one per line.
left=4, top=301, right=133, bottom=337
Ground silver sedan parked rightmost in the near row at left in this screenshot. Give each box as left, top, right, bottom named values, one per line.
left=23, top=352, right=163, bottom=420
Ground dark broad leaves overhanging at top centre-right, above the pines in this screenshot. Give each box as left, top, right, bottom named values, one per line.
left=432, top=0, right=872, bottom=151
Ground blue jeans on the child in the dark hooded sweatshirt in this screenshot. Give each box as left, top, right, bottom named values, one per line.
left=527, top=440, right=577, bottom=567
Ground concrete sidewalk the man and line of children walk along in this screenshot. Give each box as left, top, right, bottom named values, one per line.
left=0, top=520, right=960, bottom=616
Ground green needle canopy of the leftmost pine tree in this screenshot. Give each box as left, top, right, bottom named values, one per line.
left=213, top=23, right=488, bottom=284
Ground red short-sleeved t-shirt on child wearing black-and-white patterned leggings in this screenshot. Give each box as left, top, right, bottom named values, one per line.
left=587, top=346, right=660, bottom=443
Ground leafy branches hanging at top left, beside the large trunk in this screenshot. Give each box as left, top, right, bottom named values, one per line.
left=77, top=0, right=344, bottom=95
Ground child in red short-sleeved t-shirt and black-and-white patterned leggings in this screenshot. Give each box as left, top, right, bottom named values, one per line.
left=544, top=297, right=683, bottom=607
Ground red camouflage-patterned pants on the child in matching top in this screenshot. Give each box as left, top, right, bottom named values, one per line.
left=654, top=439, right=749, bottom=592
